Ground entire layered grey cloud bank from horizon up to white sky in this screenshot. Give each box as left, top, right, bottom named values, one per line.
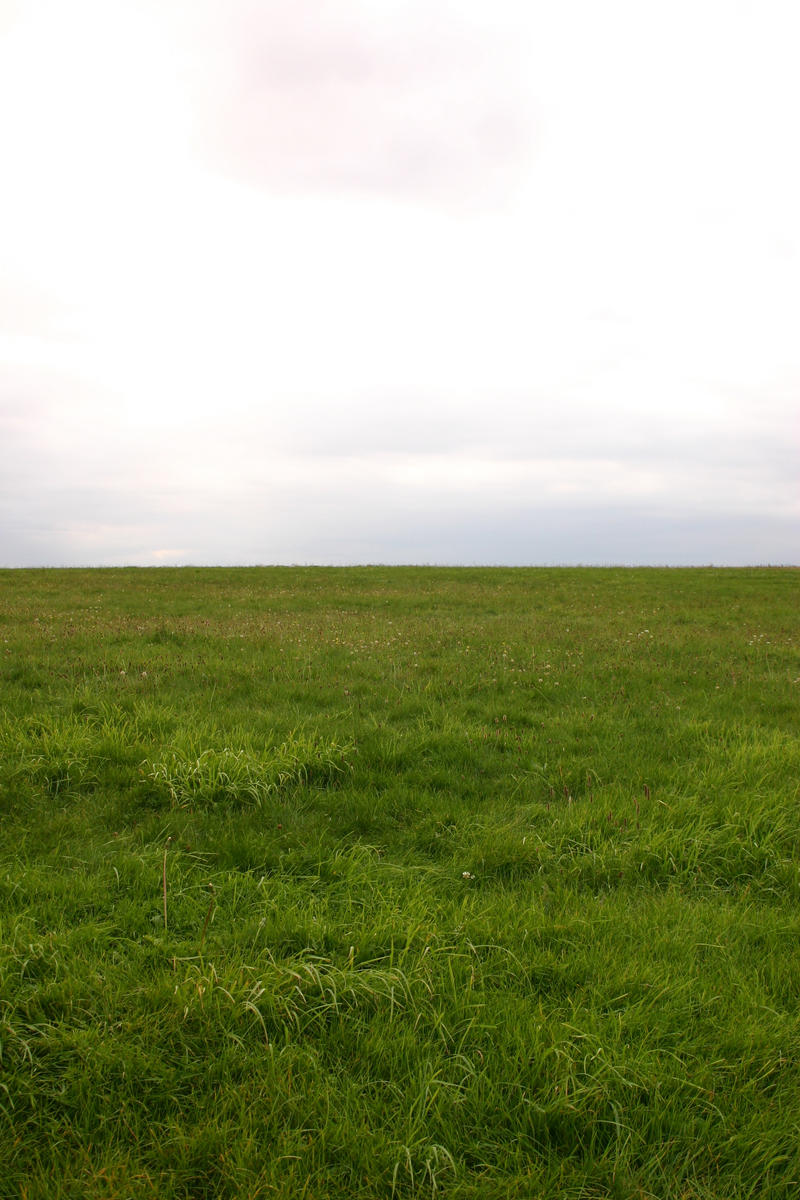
left=0, top=379, right=800, bottom=565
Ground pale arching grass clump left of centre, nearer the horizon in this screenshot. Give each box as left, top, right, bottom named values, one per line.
left=143, top=734, right=353, bottom=809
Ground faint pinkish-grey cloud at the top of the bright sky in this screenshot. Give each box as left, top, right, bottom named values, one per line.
left=159, top=0, right=531, bottom=206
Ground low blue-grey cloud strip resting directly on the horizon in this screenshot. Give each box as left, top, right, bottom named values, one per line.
left=6, top=493, right=800, bottom=566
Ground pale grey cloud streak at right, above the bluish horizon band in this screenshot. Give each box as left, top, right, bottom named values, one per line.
left=208, top=380, right=798, bottom=486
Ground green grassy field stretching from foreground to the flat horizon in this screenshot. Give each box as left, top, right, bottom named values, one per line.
left=0, top=568, right=800, bottom=1200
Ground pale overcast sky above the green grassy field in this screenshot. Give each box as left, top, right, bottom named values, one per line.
left=0, top=0, right=800, bottom=566
